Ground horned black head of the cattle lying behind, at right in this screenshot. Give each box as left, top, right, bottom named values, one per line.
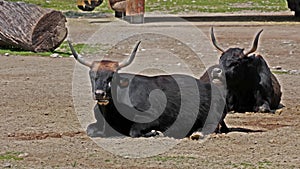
left=211, top=28, right=263, bottom=83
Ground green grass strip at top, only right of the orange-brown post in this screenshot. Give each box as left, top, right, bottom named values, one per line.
left=145, top=0, right=288, bottom=14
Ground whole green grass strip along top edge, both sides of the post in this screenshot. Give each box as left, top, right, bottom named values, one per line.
left=9, top=0, right=288, bottom=14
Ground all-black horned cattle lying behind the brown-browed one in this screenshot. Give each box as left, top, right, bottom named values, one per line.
left=200, top=28, right=281, bottom=113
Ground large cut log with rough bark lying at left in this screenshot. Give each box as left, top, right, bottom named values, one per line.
left=0, top=0, right=68, bottom=52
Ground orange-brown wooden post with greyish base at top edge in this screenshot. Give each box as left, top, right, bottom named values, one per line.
left=126, top=0, right=145, bottom=23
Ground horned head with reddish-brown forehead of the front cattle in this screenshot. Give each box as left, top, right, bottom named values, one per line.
left=68, top=41, right=141, bottom=106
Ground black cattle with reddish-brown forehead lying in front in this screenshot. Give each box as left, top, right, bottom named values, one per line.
left=69, top=43, right=225, bottom=138
